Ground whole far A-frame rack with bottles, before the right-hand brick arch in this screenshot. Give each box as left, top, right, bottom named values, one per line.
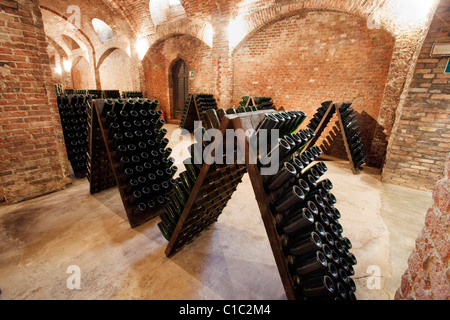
left=307, top=101, right=367, bottom=174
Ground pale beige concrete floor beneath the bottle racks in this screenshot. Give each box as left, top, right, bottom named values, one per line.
left=0, top=125, right=431, bottom=300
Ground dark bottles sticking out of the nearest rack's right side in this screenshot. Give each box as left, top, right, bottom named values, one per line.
left=256, top=112, right=357, bottom=300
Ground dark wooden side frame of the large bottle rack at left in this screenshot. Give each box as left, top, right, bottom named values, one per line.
left=89, top=100, right=171, bottom=228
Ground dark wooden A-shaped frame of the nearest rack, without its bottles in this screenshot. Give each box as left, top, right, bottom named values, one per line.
left=165, top=110, right=296, bottom=300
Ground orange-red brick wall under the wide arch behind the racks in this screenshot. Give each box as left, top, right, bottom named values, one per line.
left=232, top=12, right=394, bottom=165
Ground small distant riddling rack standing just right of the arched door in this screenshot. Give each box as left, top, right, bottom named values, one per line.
left=180, top=93, right=217, bottom=132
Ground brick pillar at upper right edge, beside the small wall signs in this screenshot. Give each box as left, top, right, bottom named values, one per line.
left=383, top=1, right=450, bottom=189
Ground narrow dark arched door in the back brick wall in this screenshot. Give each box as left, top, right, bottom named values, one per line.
left=170, top=59, right=189, bottom=119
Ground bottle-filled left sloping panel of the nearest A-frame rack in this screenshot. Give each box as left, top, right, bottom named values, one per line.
left=158, top=108, right=246, bottom=249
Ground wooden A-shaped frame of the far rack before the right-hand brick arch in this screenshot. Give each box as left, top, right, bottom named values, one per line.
left=303, top=101, right=360, bottom=174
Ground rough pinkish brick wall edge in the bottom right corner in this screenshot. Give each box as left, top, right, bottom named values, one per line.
left=395, top=154, right=450, bottom=300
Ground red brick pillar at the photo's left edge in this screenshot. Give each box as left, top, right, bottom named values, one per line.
left=0, top=0, right=70, bottom=203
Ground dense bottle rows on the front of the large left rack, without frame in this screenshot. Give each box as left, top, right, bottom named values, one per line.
left=97, top=99, right=178, bottom=216
